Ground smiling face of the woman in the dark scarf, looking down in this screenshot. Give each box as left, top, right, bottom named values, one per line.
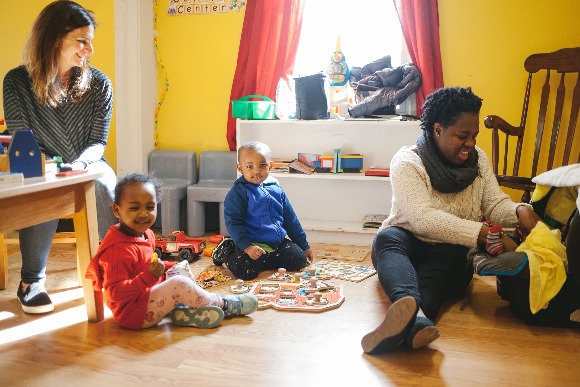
left=433, top=113, right=479, bottom=165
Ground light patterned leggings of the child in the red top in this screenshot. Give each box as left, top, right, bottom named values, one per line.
left=143, top=275, right=223, bottom=328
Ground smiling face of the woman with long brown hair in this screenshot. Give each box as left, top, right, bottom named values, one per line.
left=58, top=25, right=95, bottom=76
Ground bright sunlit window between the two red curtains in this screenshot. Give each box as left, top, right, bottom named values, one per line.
left=294, top=0, right=409, bottom=76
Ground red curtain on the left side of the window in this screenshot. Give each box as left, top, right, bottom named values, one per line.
left=226, top=0, right=304, bottom=150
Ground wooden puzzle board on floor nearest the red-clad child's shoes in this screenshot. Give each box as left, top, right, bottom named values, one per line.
left=250, top=281, right=344, bottom=312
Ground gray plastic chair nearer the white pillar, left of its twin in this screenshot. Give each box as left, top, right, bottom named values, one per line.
left=149, top=150, right=197, bottom=236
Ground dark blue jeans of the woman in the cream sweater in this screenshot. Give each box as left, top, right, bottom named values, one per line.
left=371, top=227, right=473, bottom=320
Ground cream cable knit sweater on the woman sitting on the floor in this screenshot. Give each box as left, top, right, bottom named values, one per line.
left=379, top=145, right=518, bottom=247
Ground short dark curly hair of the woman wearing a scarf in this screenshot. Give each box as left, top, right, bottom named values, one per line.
left=421, top=87, right=483, bottom=134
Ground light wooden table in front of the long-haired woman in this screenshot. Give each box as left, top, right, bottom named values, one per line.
left=0, top=172, right=104, bottom=322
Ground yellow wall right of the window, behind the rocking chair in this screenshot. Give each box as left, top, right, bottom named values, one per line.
left=439, top=0, right=580, bottom=199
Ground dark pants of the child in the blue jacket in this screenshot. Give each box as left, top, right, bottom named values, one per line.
left=225, top=239, right=308, bottom=280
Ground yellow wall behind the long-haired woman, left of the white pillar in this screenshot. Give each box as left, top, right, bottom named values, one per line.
left=0, top=0, right=117, bottom=169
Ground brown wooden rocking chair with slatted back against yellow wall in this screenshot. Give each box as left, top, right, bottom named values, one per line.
left=484, top=47, right=580, bottom=202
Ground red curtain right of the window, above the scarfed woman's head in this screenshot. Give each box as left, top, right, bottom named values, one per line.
left=393, top=0, right=443, bottom=116
